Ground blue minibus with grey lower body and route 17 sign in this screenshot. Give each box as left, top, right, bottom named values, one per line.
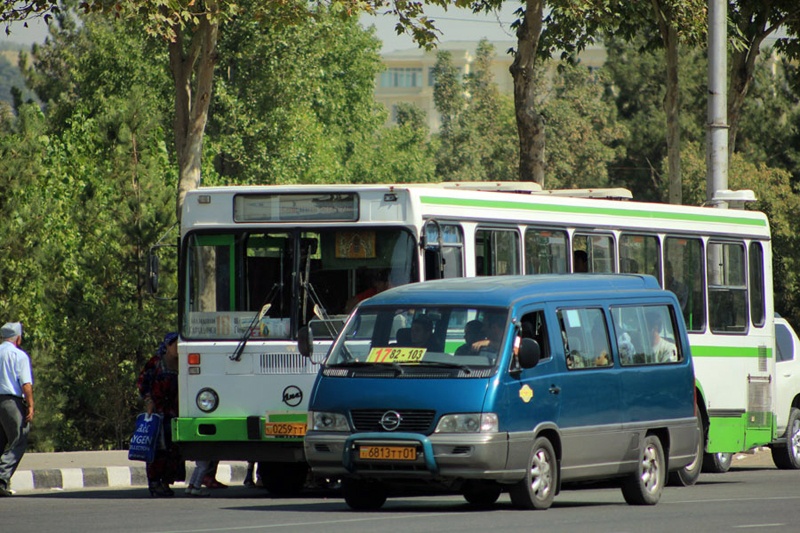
left=300, top=274, right=702, bottom=510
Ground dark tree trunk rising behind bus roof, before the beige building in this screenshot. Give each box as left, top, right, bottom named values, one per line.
left=509, top=0, right=545, bottom=187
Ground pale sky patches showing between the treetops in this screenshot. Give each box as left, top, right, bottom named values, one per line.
left=0, top=2, right=520, bottom=53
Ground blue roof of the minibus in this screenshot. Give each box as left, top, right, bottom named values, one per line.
left=363, top=274, right=661, bottom=307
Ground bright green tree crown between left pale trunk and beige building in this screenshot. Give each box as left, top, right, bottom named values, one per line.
left=206, top=5, right=382, bottom=184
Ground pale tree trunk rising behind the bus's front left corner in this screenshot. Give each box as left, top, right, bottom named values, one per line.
left=169, top=7, right=219, bottom=221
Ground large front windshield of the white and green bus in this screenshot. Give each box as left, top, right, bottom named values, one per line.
left=180, top=227, right=418, bottom=340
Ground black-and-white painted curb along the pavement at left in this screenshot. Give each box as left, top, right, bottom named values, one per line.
left=10, top=463, right=247, bottom=492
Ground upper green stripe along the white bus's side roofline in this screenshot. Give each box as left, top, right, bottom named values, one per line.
left=420, top=196, right=767, bottom=228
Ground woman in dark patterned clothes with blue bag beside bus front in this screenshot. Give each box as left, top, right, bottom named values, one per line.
left=136, top=333, right=186, bottom=497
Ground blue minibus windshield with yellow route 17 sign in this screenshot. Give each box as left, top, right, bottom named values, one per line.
left=326, top=306, right=508, bottom=369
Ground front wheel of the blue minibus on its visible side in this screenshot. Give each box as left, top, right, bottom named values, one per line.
left=509, top=437, right=558, bottom=509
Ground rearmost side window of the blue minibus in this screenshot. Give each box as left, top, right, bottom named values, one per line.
left=611, top=305, right=683, bottom=366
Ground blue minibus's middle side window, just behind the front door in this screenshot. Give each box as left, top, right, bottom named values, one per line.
left=558, top=309, right=614, bottom=370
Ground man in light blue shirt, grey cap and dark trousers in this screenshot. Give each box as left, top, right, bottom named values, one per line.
left=0, top=322, right=33, bottom=496
